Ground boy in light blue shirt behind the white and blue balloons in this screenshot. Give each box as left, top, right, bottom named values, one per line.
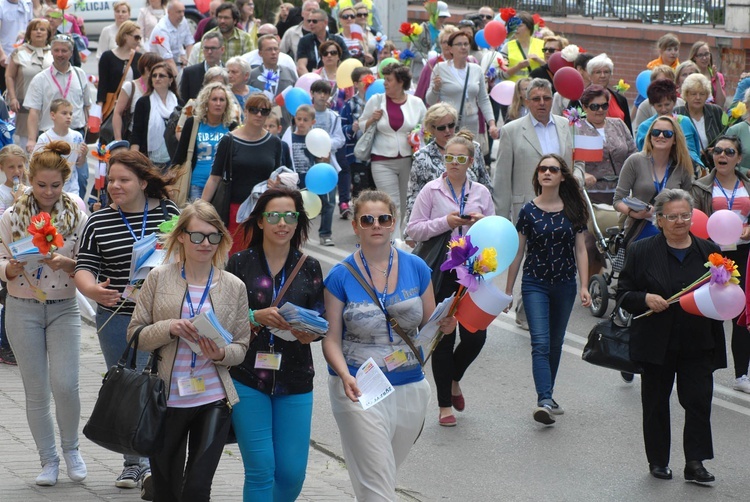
left=310, top=80, right=351, bottom=234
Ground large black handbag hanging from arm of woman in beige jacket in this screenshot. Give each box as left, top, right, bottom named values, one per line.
left=83, top=328, right=167, bottom=457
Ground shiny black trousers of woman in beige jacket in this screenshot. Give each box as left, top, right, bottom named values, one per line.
left=150, top=399, right=232, bottom=502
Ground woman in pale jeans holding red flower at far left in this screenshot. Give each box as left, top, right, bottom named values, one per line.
left=0, top=141, right=87, bottom=486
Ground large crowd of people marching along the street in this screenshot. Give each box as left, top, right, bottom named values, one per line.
left=0, top=0, right=750, bottom=501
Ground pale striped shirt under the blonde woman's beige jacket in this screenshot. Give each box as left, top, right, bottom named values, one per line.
left=167, top=282, right=227, bottom=408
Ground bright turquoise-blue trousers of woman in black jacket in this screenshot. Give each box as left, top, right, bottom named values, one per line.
left=232, top=380, right=313, bottom=502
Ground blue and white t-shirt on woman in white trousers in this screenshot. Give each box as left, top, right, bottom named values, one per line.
left=324, top=251, right=430, bottom=385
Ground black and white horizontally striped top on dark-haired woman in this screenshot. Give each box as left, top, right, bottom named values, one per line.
left=76, top=200, right=180, bottom=315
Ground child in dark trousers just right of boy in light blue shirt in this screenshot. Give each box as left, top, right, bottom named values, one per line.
left=339, top=66, right=375, bottom=199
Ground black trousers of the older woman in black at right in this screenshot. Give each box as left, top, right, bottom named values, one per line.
left=641, top=350, right=714, bottom=467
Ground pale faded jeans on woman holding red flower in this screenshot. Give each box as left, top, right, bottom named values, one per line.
left=5, top=295, right=81, bottom=465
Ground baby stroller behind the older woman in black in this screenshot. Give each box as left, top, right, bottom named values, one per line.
left=583, top=190, right=628, bottom=321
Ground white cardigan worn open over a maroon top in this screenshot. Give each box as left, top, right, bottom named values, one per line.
left=359, top=94, right=427, bottom=158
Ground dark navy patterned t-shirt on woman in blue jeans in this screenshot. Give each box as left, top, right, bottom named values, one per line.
left=516, top=202, right=583, bottom=284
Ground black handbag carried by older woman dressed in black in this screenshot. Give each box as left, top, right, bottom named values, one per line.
left=581, top=293, right=643, bottom=373
